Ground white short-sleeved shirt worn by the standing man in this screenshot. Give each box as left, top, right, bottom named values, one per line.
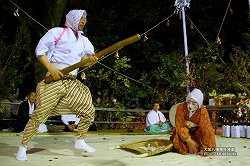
left=36, top=27, right=95, bottom=66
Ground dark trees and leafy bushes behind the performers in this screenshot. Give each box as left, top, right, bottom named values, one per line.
left=0, top=0, right=250, bottom=109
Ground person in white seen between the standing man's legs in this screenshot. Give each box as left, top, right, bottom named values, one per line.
left=61, top=114, right=80, bottom=132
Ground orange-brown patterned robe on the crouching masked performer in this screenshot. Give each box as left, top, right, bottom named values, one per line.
left=172, top=102, right=216, bottom=154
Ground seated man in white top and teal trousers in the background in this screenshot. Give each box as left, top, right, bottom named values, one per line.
left=144, top=103, right=170, bottom=133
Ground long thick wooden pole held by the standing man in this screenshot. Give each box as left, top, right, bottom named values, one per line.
left=44, top=34, right=141, bottom=84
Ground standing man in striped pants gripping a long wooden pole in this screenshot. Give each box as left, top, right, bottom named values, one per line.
left=16, top=10, right=98, bottom=160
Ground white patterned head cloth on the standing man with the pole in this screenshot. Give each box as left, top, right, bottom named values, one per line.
left=65, top=10, right=87, bottom=32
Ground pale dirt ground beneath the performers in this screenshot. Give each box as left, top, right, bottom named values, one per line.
left=0, top=132, right=250, bottom=166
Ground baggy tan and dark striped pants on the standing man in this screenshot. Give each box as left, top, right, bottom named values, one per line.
left=21, top=79, right=95, bottom=146
